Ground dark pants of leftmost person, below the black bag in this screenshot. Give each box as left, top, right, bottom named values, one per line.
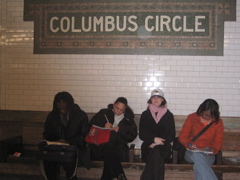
left=43, top=160, right=77, bottom=180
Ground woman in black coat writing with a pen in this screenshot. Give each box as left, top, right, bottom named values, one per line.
left=90, top=97, right=137, bottom=180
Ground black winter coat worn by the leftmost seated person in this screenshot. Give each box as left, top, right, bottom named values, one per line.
left=43, top=104, right=89, bottom=150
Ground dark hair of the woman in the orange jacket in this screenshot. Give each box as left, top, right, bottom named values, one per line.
left=197, top=99, right=220, bottom=123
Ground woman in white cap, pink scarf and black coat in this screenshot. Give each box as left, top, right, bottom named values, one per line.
left=139, top=89, right=175, bottom=180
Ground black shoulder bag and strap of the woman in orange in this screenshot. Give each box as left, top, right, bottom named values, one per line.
left=173, top=121, right=215, bottom=161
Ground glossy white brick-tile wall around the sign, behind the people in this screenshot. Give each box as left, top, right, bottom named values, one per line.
left=0, top=0, right=240, bottom=117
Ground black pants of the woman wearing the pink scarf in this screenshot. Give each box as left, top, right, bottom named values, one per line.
left=141, top=145, right=171, bottom=180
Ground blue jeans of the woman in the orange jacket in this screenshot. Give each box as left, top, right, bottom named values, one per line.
left=184, top=150, right=217, bottom=180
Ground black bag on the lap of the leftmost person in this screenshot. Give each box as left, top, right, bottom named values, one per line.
left=38, top=141, right=79, bottom=162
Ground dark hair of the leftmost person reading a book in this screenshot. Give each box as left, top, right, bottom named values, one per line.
left=53, top=91, right=74, bottom=110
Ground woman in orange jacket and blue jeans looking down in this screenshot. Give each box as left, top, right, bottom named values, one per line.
left=178, top=99, right=223, bottom=180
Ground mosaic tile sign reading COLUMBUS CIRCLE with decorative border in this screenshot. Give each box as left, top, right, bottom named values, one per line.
left=24, top=0, right=236, bottom=56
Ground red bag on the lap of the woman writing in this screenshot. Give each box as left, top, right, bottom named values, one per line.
left=85, top=125, right=111, bottom=145
